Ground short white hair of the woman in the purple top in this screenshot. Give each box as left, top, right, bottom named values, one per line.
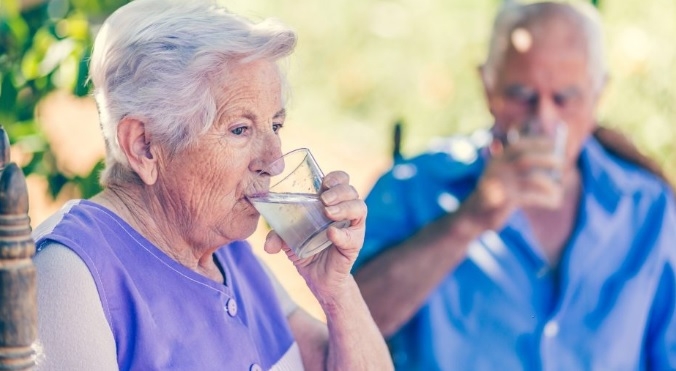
left=90, top=0, right=296, bottom=185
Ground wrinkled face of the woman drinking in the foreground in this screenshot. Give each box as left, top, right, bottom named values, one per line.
left=157, top=61, right=285, bottom=246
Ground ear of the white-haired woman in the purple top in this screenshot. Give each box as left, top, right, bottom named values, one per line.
left=117, top=117, right=159, bottom=185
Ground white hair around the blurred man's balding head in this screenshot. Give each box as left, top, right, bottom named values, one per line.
left=483, top=0, right=606, bottom=88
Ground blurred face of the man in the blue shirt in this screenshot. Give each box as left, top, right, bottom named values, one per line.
left=486, top=23, right=600, bottom=167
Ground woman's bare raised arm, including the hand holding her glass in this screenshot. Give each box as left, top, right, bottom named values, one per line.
left=265, top=172, right=394, bottom=371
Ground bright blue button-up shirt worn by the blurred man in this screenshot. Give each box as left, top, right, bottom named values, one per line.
left=355, top=138, right=676, bottom=370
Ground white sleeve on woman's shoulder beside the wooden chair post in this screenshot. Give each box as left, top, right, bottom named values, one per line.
left=34, top=243, right=118, bottom=371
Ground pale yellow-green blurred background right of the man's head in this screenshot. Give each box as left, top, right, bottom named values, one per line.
left=600, top=0, right=676, bottom=182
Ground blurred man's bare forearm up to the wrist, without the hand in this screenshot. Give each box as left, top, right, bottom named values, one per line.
left=355, top=203, right=485, bottom=337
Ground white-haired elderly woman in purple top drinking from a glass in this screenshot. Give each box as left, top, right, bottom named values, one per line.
left=35, top=0, right=392, bottom=370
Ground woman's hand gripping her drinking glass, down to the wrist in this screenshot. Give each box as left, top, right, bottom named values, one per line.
left=265, top=171, right=366, bottom=302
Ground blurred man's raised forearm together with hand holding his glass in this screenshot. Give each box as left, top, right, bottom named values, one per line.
left=355, top=138, right=563, bottom=337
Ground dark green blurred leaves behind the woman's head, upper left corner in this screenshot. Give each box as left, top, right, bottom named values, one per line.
left=0, top=0, right=127, bottom=197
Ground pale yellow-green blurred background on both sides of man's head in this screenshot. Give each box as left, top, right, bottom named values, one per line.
left=225, top=0, right=676, bottom=180
